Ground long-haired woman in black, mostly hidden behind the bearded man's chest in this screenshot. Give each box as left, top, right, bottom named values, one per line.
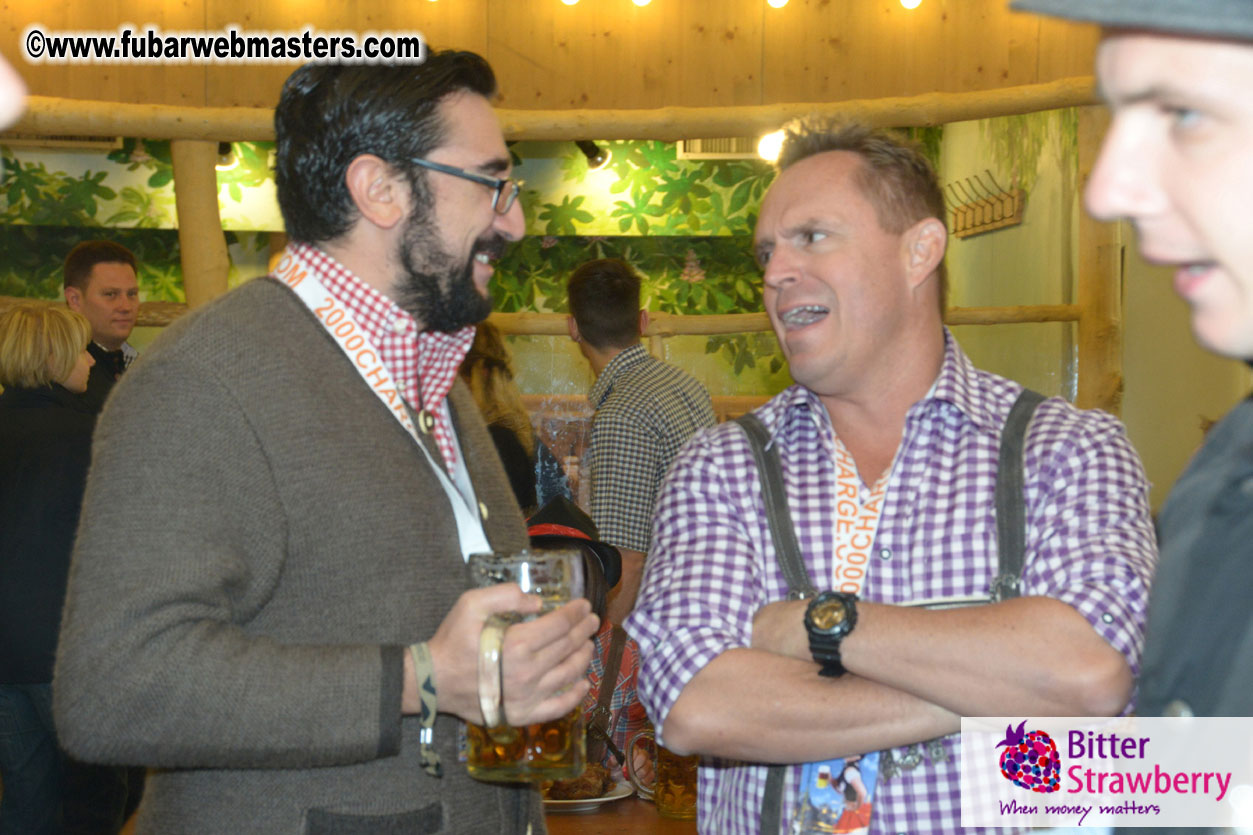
left=461, top=322, right=573, bottom=517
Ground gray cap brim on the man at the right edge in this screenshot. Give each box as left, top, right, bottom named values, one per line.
left=1010, top=0, right=1253, bottom=40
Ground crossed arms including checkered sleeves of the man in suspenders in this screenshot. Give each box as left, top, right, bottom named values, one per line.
left=628, top=413, right=1155, bottom=762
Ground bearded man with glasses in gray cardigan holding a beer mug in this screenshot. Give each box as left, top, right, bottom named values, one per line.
left=54, top=51, right=596, bottom=835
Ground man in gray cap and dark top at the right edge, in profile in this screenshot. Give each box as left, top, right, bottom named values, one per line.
left=1012, top=0, right=1253, bottom=737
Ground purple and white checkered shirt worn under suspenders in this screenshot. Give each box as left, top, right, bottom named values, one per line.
left=625, top=331, right=1157, bottom=835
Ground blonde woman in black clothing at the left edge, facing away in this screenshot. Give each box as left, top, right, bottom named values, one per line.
left=0, top=302, right=95, bottom=832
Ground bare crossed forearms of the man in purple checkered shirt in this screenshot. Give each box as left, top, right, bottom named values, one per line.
left=665, top=598, right=1133, bottom=762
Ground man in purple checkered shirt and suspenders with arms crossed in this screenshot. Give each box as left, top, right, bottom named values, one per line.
left=625, top=123, right=1157, bottom=835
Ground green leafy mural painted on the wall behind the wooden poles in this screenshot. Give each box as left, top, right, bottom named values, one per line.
left=0, top=112, right=1074, bottom=395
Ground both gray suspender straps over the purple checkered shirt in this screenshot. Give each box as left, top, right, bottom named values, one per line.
left=736, top=389, right=1044, bottom=835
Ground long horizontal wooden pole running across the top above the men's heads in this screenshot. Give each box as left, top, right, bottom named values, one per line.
left=4, top=75, right=1099, bottom=142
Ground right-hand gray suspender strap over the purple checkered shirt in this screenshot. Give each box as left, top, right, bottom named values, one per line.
left=987, top=389, right=1044, bottom=603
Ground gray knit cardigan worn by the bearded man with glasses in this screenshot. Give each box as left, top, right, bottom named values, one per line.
left=54, top=280, right=544, bottom=835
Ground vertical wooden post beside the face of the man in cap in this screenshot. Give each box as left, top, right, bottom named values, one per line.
left=1075, top=107, right=1123, bottom=415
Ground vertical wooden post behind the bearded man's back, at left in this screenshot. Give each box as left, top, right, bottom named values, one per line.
left=169, top=139, right=231, bottom=310
